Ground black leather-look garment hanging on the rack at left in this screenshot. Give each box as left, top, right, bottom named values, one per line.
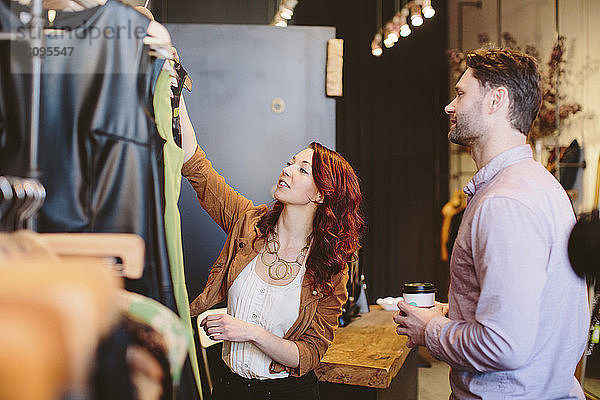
left=0, top=0, right=175, bottom=310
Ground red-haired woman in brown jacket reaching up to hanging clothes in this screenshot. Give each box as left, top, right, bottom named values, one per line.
left=180, top=97, right=363, bottom=399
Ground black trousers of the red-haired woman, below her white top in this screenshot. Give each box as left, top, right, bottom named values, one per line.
left=212, top=368, right=319, bottom=400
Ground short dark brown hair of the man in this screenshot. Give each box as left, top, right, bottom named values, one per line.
left=466, top=49, right=542, bottom=136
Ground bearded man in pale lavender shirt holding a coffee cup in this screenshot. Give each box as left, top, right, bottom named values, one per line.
left=394, top=49, right=589, bottom=400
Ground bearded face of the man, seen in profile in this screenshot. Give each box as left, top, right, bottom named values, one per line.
left=444, top=68, right=487, bottom=146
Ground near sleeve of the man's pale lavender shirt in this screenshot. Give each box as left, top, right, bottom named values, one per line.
left=425, top=197, right=552, bottom=372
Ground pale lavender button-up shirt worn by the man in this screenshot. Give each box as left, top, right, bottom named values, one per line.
left=425, top=145, right=590, bottom=400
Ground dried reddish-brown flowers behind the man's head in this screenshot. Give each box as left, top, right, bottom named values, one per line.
left=446, top=32, right=582, bottom=141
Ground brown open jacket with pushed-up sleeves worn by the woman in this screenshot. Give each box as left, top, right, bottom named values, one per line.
left=181, top=147, right=348, bottom=376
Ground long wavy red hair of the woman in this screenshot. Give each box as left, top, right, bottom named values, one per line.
left=252, top=142, right=364, bottom=294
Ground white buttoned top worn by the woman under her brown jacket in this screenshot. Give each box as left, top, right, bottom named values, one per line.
left=222, top=256, right=306, bottom=379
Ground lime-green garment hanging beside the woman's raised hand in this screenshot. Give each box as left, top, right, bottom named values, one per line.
left=153, top=64, right=202, bottom=399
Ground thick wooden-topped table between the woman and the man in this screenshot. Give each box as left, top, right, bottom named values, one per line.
left=315, top=305, right=417, bottom=400
